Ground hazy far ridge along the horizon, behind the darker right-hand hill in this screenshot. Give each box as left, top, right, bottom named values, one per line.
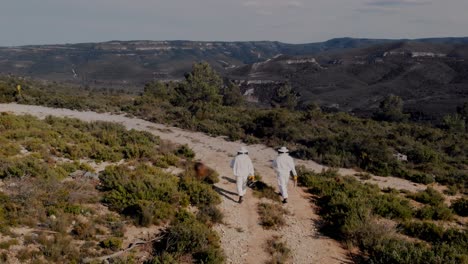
left=0, top=38, right=468, bottom=86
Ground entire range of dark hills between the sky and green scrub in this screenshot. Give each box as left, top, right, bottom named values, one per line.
left=0, top=38, right=468, bottom=117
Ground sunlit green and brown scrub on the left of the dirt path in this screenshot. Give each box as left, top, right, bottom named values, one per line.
left=0, top=113, right=224, bottom=263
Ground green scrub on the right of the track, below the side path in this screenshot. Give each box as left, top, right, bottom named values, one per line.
left=299, top=169, right=468, bottom=263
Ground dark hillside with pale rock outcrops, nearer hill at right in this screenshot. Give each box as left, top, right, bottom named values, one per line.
left=228, top=40, right=468, bottom=119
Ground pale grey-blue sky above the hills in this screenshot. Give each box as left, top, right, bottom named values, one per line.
left=0, top=0, right=468, bottom=46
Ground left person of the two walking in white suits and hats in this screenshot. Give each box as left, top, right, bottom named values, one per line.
left=231, top=147, right=254, bottom=203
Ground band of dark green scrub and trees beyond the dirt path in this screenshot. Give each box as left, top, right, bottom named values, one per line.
left=0, top=63, right=468, bottom=192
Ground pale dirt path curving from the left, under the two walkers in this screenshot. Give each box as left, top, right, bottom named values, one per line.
left=0, top=104, right=438, bottom=264
